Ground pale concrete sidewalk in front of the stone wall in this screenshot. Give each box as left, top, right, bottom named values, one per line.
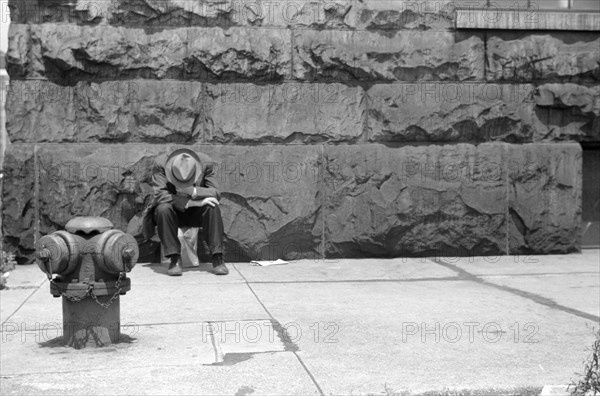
left=0, top=250, right=600, bottom=395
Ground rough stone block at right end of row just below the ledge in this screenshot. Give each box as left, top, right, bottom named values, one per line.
left=486, top=32, right=600, bottom=83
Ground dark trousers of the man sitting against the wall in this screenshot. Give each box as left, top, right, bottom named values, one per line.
left=154, top=203, right=223, bottom=257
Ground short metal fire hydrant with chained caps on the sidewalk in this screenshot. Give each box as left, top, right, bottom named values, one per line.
left=36, top=217, right=139, bottom=349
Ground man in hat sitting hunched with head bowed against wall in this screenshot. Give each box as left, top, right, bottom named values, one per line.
left=147, top=148, right=229, bottom=276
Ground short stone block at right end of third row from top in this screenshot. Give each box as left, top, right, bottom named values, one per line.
left=534, top=83, right=600, bottom=142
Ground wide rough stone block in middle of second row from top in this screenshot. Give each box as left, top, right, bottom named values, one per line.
left=294, top=30, right=484, bottom=82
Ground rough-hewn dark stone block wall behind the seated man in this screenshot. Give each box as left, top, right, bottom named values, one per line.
left=2, top=0, right=600, bottom=261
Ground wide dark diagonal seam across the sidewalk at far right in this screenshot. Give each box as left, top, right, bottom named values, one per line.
left=429, top=258, right=600, bottom=322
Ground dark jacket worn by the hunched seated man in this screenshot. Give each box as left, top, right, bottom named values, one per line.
left=142, top=153, right=221, bottom=239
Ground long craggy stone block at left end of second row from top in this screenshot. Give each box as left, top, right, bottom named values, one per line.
left=7, top=24, right=188, bottom=81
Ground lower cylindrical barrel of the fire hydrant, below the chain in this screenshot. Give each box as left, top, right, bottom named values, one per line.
left=62, top=296, right=121, bottom=349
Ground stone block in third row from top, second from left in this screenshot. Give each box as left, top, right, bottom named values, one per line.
left=77, top=80, right=204, bottom=143
